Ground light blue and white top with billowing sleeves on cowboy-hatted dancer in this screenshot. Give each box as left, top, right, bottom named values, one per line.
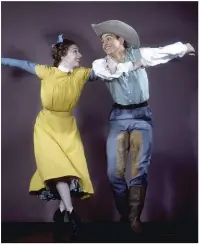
left=93, top=42, right=187, bottom=105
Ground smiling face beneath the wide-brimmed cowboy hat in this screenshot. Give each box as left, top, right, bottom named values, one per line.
left=101, top=33, right=124, bottom=55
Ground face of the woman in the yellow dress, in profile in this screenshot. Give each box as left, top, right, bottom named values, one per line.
left=61, top=44, right=82, bottom=69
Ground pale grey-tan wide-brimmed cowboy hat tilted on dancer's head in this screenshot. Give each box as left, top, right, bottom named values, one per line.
left=92, top=20, right=140, bottom=48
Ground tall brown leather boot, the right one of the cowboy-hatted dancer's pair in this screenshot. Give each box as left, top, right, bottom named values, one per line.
left=129, top=186, right=147, bottom=233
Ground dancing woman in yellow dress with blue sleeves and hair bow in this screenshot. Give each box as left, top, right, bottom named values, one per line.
left=1, top=35, right=95, bottom=233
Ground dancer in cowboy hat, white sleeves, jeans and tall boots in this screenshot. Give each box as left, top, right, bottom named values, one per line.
left=92, top=20, right=195, bottom=232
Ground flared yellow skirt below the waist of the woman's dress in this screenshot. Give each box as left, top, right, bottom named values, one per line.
left=29, top=109, right=94, bottom=199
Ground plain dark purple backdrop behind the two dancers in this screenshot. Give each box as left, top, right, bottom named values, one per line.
left=1, top=2, right=198, bottom=221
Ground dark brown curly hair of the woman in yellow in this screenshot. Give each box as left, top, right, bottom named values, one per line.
left=52, top=39, right=76, bottom=67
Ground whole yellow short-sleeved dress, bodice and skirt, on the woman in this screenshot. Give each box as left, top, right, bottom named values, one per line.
left=29, top=65, right=94, bottom=199
